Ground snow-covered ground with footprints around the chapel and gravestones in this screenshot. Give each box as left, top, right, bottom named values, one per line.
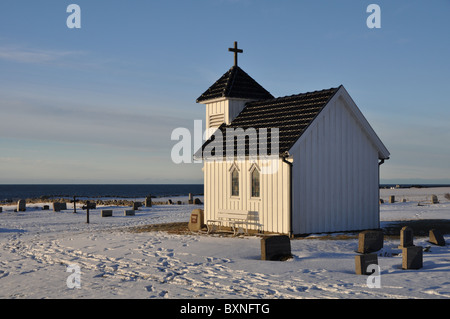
left=0, top=188, right=450, bottom=299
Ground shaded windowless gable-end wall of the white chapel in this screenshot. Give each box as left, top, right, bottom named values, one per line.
left=291, top=98, right=379, bottom=234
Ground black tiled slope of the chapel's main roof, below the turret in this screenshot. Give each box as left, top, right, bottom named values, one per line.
left=195, top=86, right=341, bottom=158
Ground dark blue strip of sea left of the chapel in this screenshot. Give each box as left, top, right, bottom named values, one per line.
left=0, top=184, right=203, bottom=201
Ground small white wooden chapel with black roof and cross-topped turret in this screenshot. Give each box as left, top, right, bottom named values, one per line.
left=196, top=42, right=390, bottom=235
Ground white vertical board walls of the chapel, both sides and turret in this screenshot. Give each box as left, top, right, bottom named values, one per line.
left=204, top=92, right=379, bottom=234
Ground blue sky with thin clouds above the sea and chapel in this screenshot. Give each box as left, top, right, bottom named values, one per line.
left=0, top=0, right=450, bottom=184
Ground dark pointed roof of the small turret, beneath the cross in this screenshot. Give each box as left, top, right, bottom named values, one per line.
left=197, top=66, right=273, bottom=103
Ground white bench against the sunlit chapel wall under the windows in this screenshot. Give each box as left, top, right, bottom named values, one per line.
left=206, top=209, right=262, bottom=235
